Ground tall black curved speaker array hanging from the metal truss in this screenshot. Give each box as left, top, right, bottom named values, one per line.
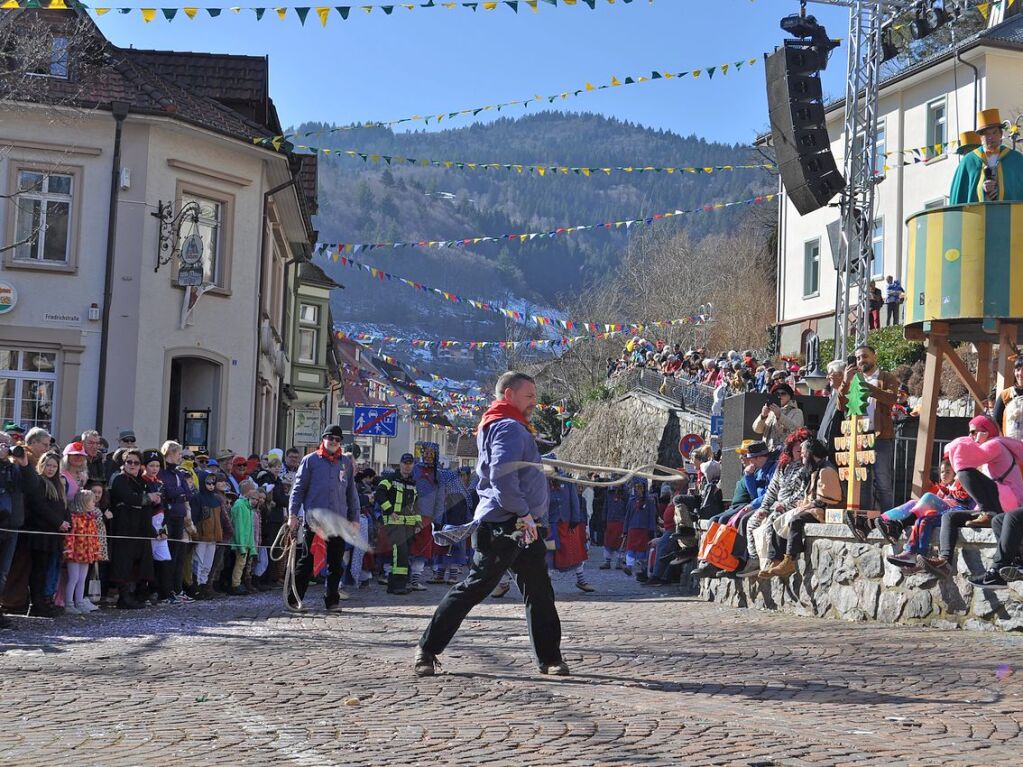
left=765, top=44, right=845, bottom=216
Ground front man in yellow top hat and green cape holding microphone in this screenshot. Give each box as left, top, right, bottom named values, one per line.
left=948, top=109, right=1023, bottom=206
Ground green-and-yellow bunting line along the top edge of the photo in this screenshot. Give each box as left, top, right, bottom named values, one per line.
left=7, top=0, right=654, bottom=27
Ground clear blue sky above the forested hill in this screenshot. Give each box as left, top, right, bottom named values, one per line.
left=97, top=0, right=847, bottom=145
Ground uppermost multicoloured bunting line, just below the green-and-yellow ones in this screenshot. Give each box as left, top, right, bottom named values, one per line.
left=320, top=192, right=780, bottom=258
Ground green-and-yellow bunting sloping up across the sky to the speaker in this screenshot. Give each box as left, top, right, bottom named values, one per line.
left=259, top=55, right=760, bottom=151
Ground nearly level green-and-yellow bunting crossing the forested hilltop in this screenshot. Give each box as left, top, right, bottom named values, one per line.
left=295, top=144, right=777, bottom=177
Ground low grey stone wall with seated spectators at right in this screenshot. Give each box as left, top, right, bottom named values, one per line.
left=700, top=525, right=1023, bottom=631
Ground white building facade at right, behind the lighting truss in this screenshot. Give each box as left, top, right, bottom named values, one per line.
left=777, top=16, right=1023, bottom=354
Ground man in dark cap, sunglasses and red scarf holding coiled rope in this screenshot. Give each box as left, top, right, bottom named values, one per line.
left=287, top=424, right=361, bottom=612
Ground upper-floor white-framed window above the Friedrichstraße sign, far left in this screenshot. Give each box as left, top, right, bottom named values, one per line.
left=13, top=168, right=75, bottom=266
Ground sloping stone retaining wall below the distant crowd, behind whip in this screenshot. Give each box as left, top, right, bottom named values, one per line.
left=558, top=391, right=710, bottom=468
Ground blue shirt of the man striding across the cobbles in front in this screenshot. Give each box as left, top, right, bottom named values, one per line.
left=474, top=418, right=548, bottom=527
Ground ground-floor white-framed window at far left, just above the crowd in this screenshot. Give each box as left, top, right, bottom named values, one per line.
left=0, top=348, right=57, bottom=432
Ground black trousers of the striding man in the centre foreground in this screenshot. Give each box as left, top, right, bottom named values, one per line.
left=419, top=521, right=562, bottom=665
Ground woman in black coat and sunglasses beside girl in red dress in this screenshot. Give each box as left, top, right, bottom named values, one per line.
left=107, top=448, right=161, bottom=610
